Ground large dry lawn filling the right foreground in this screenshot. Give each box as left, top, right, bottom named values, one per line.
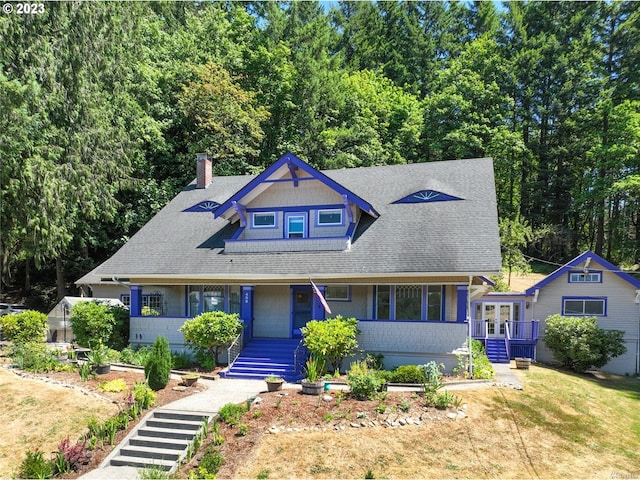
left=234, top=366, right=640, bottom=478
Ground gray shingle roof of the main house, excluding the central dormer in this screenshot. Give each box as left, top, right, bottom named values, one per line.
left=77, top=158, right=501, bottom=284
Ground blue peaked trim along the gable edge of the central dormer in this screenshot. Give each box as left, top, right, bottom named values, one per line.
left=213, top=152, right=379, bottom=218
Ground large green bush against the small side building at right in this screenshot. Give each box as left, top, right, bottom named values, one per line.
left=544, top=314, right=627, bottom=372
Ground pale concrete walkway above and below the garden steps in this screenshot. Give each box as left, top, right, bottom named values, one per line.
left=80, top=378, right=266, bottom=480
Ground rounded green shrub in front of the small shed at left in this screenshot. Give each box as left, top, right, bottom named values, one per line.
left=71, top=302, right=116, bottom=347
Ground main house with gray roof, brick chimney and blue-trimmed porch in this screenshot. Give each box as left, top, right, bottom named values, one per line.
left=77, top=153, right=501, bottom=375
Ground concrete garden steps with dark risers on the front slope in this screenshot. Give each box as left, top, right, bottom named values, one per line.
left=109, top=408, right=213, bottom=472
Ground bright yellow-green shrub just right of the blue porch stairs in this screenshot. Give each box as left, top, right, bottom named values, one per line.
left=300, top=315, right=360, bottom=372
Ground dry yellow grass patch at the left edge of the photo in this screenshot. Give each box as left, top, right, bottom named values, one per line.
left=0, top=368, right=118, bottom=478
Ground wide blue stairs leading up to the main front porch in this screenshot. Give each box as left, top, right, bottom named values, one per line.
left=220, top=338, right=301, bottom=382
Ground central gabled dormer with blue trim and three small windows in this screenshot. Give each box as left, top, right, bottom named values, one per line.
left=214, top=153, right=378, bottom=253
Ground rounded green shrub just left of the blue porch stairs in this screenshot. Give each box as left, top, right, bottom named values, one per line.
left=178, top=312, right=242, bottom=365
